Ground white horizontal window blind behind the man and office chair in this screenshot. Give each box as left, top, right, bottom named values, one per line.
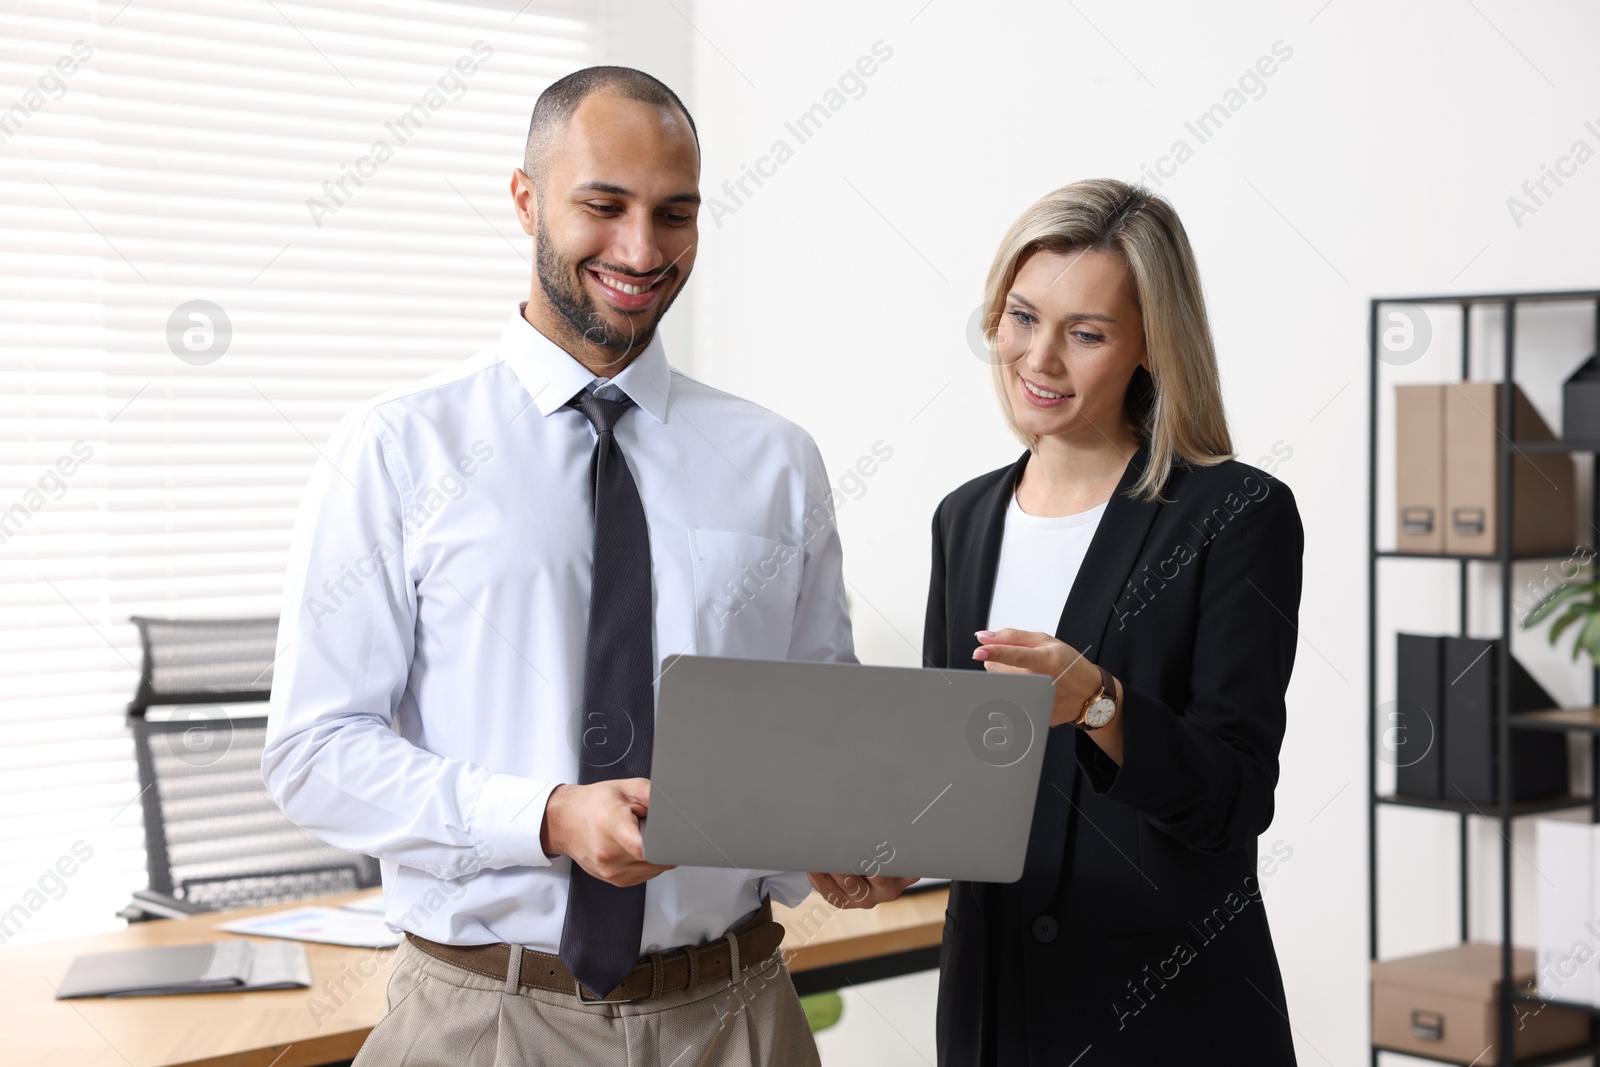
left=0, top=0, right=603, bottom=944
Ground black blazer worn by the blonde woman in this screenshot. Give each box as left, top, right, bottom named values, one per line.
left=923, top=445, right=1304, bottom=1067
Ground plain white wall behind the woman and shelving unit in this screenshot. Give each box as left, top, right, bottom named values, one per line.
left=652, top=0, right=1600, bottom=1064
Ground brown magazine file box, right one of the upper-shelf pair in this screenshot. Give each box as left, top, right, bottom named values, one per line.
left=1443, top=382, right=1576, bottom=555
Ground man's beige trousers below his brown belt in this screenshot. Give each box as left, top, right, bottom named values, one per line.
left=354, top=941, right=821, bottom=1067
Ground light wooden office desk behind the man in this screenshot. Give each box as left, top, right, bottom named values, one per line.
left=0, top=888, right=947, bottom=1067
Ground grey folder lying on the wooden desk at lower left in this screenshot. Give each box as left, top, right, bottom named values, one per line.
left=56, top=941, right=310, bottom=1000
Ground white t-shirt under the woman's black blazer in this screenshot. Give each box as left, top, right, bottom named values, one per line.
left=989, top=493, right=1106, bottom=635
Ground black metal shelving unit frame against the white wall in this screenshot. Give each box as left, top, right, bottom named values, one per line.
left=1366, top=290, right=1600, bottom=1067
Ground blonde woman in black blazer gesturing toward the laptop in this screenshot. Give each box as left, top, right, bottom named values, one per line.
left=923, top=179, right=1304, bottom=1067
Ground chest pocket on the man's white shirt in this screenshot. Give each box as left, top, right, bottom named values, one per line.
left=690, top=530, right=800, bottom=659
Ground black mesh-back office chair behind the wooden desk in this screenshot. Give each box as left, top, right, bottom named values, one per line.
left=120, top=616, right=381, bottom=921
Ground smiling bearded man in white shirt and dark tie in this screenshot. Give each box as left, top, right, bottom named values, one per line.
left=262, top=67, right=899, bottom=1067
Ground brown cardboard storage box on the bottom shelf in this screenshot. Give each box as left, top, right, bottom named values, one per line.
left=1373, top=942, right=1589, bottom=1064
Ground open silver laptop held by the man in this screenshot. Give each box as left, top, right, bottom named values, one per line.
left=645, top=656, right=1054, bottom=881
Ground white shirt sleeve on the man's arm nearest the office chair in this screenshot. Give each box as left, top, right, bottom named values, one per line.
left=261, top=410, right=555, bottom=878
